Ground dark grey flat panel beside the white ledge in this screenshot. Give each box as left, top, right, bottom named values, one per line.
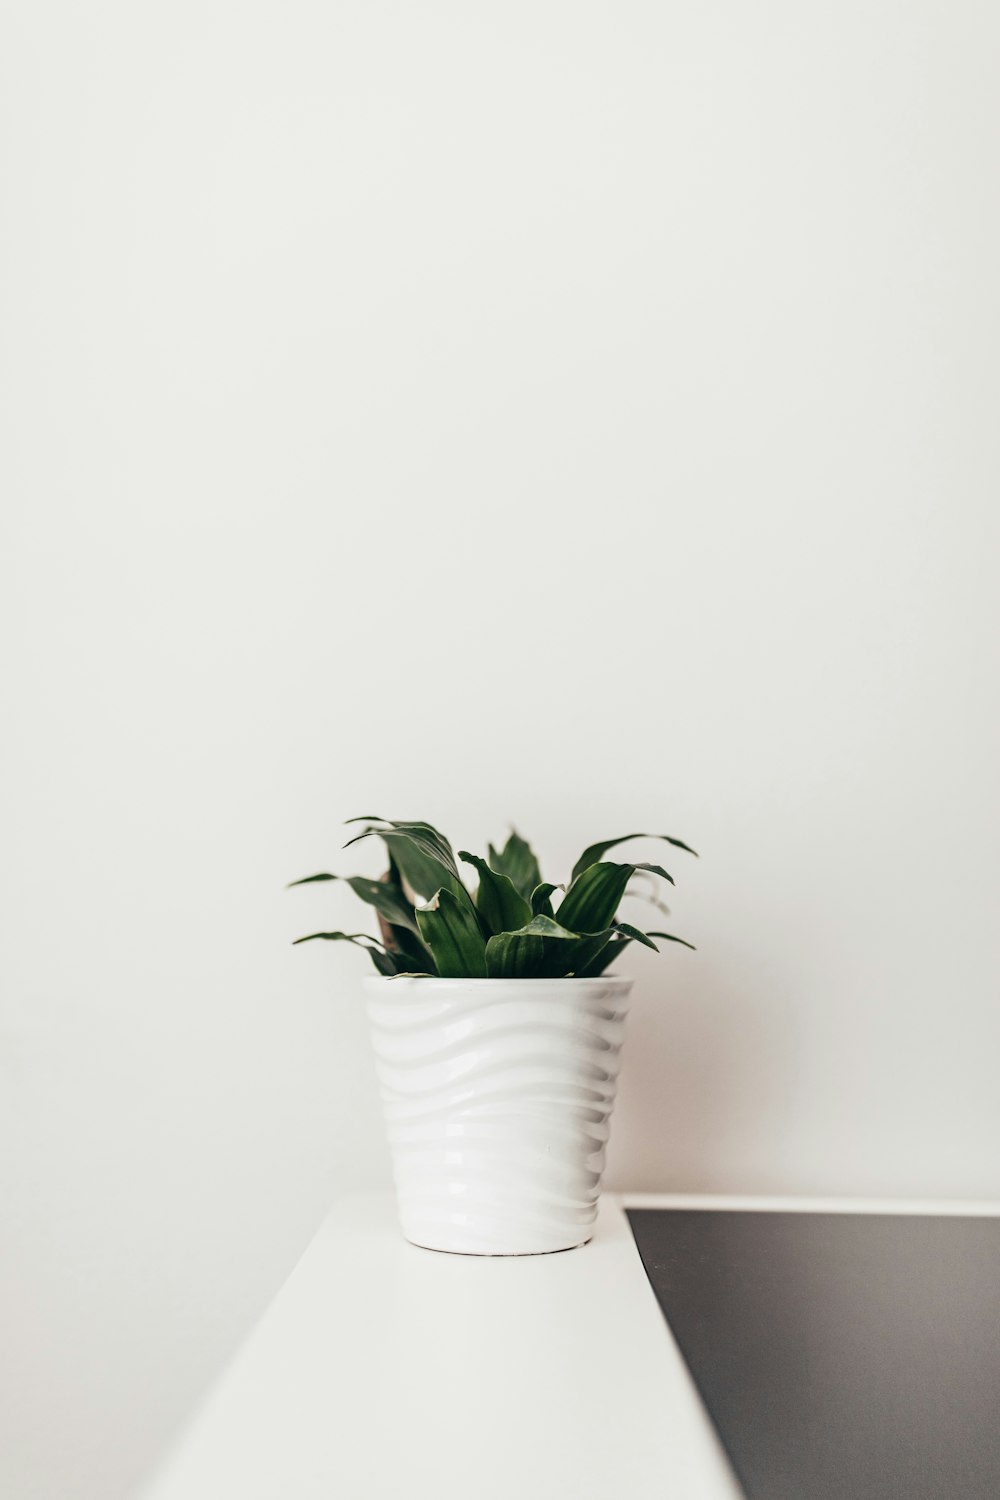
left=628, top=1209, right=1000, bottom=1500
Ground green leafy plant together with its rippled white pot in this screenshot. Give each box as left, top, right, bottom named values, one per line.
left=292, top=818, right=694, bottom=1256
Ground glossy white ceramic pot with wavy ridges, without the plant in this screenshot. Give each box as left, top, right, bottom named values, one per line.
left=366, top=978, right=631, bottom=1256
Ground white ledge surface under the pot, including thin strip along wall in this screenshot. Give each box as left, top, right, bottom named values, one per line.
left=134, top=1194, right=999, bottom=1500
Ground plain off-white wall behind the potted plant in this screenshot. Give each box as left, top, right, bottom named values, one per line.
left=0, top=0, right=1000, bottom=1500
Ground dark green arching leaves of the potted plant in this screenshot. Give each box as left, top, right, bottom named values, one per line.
left=292, top=818, right=694, bottom=980
